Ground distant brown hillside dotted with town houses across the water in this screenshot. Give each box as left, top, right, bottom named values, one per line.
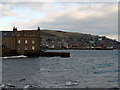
left=41, top=30, right=120, bottom=48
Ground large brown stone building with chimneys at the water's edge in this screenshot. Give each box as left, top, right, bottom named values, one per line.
left=2, top=27, right=41, bottom=54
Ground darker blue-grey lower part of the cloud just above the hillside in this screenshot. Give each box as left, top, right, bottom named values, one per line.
left=36, top=3, right=117, bottom=35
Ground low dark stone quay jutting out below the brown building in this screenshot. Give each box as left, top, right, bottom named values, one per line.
left=2, top=48, right=70, bottom=57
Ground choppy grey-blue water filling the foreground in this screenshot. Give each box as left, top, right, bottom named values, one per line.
left=3, top=50, right=118, bottom=88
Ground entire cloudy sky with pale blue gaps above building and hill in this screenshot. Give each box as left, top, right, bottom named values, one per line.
left=0, top=1, right=118, bottom=40
